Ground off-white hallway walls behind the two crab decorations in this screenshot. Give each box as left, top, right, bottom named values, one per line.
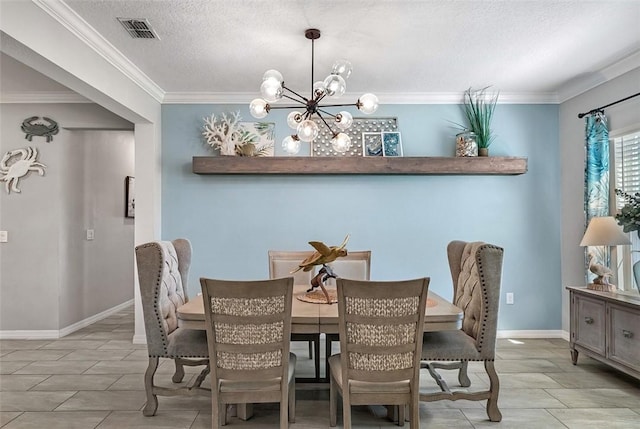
left=0, top=104, right=134, bottom=334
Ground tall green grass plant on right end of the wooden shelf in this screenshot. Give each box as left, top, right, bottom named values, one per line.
left=462, top=87, right=499, bottom=156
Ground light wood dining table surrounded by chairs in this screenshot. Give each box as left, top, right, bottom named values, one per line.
left=177, top=284, right=463, bottom=420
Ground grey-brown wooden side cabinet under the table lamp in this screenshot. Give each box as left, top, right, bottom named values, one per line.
left=567, top=287, right=640, bottom=379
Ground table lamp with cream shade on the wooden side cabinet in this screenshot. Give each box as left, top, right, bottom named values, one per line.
left=580, top=216, right=631, bottom=292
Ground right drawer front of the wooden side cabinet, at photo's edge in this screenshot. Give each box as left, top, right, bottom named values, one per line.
left=609, top=304, right=640, bottom=371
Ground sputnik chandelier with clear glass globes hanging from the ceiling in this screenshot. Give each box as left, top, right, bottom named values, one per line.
left=249, top=28, right=378, bottom=154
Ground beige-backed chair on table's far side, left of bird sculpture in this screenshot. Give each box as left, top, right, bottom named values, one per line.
left=268, top=250, right=320, bottom=381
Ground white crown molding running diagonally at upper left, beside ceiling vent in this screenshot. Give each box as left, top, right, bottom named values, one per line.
left=33, top=0, right=164, bottom=103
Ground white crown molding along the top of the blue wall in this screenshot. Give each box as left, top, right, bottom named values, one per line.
left=162, top=92, right=559, bottom=104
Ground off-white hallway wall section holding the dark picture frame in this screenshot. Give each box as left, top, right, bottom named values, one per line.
left=59, top=131, right=134, bottom=328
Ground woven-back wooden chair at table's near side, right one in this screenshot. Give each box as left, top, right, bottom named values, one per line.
left=329, top=278, right=429, bottom=429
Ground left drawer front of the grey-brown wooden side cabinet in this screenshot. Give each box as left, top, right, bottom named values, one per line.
left=573, top=295, right=606, bottom=356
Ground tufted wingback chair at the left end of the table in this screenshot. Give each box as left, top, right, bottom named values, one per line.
left=136, top=239, right=209, bottom=416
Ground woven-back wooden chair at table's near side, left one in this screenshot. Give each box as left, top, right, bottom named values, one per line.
left=200, top=277, right=296, bottom=429
